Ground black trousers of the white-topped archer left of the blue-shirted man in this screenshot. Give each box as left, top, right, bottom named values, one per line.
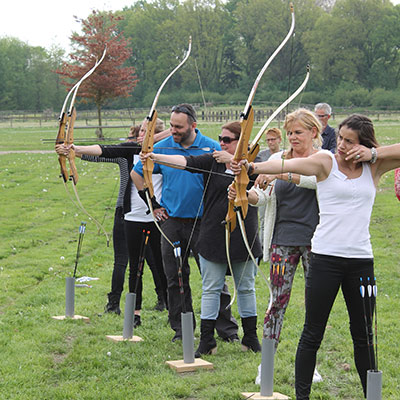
left=124, top=220, right=167, bottom=310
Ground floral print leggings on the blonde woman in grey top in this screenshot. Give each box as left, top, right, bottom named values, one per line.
left=263, top=245, right=311, bottom=348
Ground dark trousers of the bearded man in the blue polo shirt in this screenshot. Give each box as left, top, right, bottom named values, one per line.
left=161, top=217, right=238, bottom=339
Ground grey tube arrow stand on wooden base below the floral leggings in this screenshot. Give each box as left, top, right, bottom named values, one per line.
left=242, top=338, right=289, bottom=400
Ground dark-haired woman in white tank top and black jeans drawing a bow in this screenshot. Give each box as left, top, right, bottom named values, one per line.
left=232, top=114, right=400, bottom=400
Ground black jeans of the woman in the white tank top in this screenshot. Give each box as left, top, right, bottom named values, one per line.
left=295, top=253, right=375, bottom=400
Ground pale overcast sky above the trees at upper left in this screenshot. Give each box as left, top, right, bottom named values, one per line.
left=0, top=0, right=400, bottom=50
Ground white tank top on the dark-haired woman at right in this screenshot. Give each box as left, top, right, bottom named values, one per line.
left=311, top=151, right=376, bottom=258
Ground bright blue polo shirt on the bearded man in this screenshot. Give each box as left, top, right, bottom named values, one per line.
left=134, top=129, right=221, bottom=218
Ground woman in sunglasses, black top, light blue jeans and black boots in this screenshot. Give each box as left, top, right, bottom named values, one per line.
left=141, top=122, right=262, bottom=357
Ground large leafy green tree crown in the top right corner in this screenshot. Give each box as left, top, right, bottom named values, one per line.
left=304, top=0, right=400, bottom=89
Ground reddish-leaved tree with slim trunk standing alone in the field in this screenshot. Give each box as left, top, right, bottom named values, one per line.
left=56, top=11, right=138, bottom=137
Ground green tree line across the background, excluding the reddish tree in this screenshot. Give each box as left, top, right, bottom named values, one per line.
left=0, top=0, right=400, bottom=111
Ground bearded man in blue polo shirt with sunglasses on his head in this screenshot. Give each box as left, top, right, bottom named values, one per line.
left=131, top=104, right=238, bottom=341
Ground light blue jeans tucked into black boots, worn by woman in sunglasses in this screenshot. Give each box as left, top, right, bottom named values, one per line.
left=200, top=255, right=257, bottom=320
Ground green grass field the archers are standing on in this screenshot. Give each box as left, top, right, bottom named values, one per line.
left=0, top=116, right=400, bottom=400
